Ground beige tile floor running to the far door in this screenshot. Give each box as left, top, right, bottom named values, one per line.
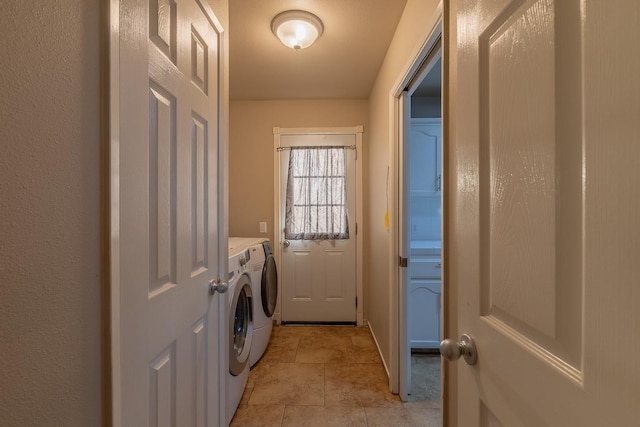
left=231, top=326, right=441, bottom=427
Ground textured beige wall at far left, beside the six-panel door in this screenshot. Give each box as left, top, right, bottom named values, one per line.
left=0, top=0, right=101, bottom=426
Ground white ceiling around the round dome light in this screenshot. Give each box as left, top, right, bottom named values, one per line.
left=229, top=0, right=406, bottom=100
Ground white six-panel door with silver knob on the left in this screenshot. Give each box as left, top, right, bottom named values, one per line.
left=111, top=0, right=227, bottom=427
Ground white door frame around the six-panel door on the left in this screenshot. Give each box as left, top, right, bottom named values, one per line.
left=106, top=0, right=229, bottom=427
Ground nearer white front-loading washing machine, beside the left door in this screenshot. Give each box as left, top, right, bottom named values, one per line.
left=227, top=249, right=253, bottom=422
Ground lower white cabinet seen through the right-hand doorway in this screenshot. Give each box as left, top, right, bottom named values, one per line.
left=409, top=255, right=442, bottom=349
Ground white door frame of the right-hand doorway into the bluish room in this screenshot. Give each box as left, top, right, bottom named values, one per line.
left=389, top=1, right=455, bottom=414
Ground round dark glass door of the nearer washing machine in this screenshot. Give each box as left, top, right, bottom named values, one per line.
left=229, top=274, right=253, bottom=375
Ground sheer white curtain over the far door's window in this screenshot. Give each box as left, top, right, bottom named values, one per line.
left=285, top=147, right=349, bottom=240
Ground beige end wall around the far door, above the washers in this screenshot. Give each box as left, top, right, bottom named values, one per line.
left=229, top=100, right=369, bottom=247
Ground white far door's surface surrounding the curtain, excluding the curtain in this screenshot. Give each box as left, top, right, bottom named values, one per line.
left=279, top=134, right=356, bottom=323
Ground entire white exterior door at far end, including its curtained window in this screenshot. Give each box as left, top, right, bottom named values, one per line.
left=279, top=134, right=356, bottom=324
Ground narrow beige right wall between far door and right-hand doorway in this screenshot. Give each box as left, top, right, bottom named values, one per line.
left=364, top=0, right=438, bottom=367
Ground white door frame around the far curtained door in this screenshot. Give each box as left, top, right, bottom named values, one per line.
left=273, top=125, right=364, bottom=326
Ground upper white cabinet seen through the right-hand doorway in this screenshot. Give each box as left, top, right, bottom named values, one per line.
left=409, top=118, right=442, bottom=196
